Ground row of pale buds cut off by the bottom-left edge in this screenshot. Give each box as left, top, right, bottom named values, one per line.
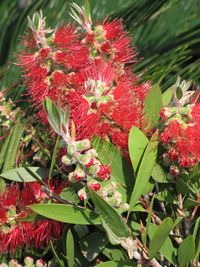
left=0, top=256, right=49, bottom=267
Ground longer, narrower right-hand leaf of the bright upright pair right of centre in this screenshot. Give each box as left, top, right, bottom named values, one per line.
left=130, top=133, right=158, bottom=211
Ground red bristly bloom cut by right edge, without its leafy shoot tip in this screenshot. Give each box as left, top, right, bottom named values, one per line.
left=160, top=104, right=200, bottom=168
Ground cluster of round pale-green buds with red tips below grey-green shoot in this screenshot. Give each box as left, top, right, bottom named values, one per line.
left=62, top=139, right=110, bottom=200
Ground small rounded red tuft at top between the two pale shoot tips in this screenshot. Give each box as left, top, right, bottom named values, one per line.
left=53, top=24, right=79, bottom=48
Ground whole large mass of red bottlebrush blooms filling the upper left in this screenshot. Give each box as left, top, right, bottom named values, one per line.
left=18, top=10, right=150, bottom=154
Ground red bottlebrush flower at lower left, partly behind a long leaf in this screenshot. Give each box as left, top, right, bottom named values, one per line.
left=0, top=181, right=63, bottom=253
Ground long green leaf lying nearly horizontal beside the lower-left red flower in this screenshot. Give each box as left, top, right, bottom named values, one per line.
left=30, top=204, right=101, bottom=225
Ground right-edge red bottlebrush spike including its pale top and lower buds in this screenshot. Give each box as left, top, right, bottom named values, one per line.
left=160, top=78, right=200, bottom=176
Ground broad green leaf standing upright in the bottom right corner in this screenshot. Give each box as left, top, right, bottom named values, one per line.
left=178, top=235, right=195, bottom=267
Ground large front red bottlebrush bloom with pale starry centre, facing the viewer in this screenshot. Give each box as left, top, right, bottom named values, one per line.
left=66, top=60, right=150, bottom=155
